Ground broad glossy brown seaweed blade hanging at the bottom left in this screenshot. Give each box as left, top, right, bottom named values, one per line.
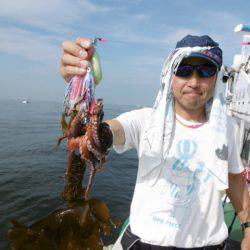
left=7, top=198, right=115, bottom=250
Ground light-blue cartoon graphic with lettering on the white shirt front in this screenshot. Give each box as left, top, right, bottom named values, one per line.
left=153, top=139, right=211, bottom=229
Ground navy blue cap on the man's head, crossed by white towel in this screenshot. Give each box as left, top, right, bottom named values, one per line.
left=175, top=35, right=222, bottom=68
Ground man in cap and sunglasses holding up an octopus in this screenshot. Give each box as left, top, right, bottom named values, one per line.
left=61, top=35, right=250, bottom=250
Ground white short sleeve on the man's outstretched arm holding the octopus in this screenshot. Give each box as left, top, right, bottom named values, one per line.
left=113, top=108, right=151, bottom=154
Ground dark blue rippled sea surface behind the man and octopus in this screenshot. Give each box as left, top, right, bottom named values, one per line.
left=0, top=100, right=138, bottom=249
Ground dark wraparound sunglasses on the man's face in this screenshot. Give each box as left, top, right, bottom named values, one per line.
left=174, top=64, right=217, bottom=77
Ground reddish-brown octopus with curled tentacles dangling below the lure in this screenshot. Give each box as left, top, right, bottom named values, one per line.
left=57, top=99, right=112, bottom=200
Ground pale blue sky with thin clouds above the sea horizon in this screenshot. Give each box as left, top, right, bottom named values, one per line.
left=0, top=0, right=250, bottom=106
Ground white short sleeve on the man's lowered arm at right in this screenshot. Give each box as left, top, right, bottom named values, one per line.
left=227, top=117, right=244, bottom=174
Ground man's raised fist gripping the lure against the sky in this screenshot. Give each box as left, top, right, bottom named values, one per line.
left=60, top=38, right=94, bottom=83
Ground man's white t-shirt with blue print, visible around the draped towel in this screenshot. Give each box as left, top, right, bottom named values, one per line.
left=114, top=108, right=243, bottom=248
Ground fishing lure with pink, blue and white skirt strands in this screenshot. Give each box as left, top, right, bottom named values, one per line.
left=63, top=37, right=107, bottom=118
